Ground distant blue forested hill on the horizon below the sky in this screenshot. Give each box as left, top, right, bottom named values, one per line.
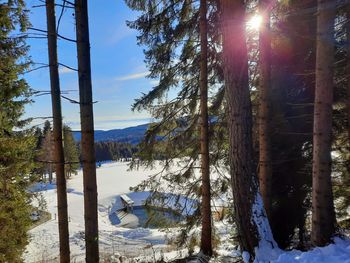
left=73, top=123, right=149, bottom=144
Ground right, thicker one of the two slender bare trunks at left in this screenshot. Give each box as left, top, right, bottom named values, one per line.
left=75, top=0, right=99, bottom=263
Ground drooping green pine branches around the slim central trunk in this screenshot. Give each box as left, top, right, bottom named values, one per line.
left=126, top=0, right=227, bottom=250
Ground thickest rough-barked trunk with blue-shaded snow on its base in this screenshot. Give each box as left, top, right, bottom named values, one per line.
left=220, top=0, right=277, bottom=260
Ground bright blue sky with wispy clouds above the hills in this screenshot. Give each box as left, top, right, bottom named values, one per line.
left=25, top=0, right=155, bottom=130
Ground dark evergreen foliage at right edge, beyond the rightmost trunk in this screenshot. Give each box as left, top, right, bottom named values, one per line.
left=332, top=2, right=350, bottom=228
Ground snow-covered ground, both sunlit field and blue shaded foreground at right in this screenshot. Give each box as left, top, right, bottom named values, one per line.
left=24, top=162, right=350, bottom=263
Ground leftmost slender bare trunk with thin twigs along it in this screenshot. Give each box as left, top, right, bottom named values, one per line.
left=46, top=0, right=70, bottom=263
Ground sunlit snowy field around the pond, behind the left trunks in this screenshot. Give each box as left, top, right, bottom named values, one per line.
left=24, top=162, right=185, bottom=262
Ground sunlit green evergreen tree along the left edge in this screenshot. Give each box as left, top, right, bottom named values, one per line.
left=0, top=1, right=36, bottom=262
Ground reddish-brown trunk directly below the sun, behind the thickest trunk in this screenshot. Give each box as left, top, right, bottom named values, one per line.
left=258, top=0, right=272, bottom=219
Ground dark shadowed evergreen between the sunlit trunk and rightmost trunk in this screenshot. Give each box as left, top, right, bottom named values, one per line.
left=264, top=0, right=317, bottom=248
